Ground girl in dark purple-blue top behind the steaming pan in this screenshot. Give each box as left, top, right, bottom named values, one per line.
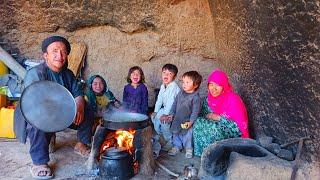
left=123, top=66, right=148, bottom=114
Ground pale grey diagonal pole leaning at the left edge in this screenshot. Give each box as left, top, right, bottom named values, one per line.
left=0, top=46, right=27, bottom=79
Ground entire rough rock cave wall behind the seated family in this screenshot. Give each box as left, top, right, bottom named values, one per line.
left=0, top=0, right=320, bottom=165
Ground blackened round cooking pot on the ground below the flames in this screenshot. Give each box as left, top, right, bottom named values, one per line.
left=99, top=147, right=134, bottom=180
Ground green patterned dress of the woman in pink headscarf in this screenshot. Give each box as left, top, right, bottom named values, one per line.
left=193, top=99, right=241, bottom=156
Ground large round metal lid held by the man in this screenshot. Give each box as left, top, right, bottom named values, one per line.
left=20, top=81, right=76, bottom=132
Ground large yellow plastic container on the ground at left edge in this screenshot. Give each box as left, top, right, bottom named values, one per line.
left=0, top=107, right=16, bottom=138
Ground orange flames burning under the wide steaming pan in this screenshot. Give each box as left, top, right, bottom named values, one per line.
left=116, top=130, right=136, bottom=153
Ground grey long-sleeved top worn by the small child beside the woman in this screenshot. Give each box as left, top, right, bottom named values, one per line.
left=170, top=91, right=201, bottom=134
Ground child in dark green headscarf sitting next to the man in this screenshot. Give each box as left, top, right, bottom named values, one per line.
left=85, top=75, right=120, bottom=132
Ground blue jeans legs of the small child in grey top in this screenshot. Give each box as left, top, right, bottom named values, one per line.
left=172, top=128, right=193, bottom=150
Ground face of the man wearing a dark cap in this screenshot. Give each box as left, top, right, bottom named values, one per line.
left=43, top=41, right=68, bottom=72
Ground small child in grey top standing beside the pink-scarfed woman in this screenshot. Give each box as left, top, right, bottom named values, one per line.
left=163, top=71, right=202, bottom=158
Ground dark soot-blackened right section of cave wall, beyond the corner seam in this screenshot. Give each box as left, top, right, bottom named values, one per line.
left=209, top=0, right=320, bottom=160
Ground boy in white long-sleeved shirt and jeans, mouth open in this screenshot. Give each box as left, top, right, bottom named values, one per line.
left=151, top=64, right=180, bottom=156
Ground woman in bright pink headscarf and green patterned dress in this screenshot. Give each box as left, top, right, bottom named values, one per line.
left=193, top=70, right=249, bottom=156
